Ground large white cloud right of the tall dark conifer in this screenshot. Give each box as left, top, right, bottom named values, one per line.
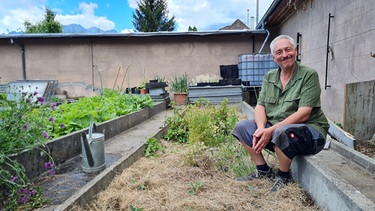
left=128, top=0, right=273, bottom=31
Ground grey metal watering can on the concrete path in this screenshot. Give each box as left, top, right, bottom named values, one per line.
left=81, top=122, right=105, bottom=173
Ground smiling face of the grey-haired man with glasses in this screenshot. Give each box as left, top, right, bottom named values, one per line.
left=272, top=39, right=297, bottom=70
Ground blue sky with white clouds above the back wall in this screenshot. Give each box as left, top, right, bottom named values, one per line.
left=0, top=0, right=273, bottom=34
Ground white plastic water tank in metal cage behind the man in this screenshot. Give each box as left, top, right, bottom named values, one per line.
left=238, top=53, right=278, bottom=86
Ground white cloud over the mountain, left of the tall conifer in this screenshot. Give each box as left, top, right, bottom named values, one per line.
left=56, top=2, right=115, bottom=30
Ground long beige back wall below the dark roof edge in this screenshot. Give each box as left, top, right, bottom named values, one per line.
left=0, top=33, right=269, bottom=97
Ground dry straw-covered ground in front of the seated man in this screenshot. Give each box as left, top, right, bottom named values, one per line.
left=72, top=140, right=320, bottom=211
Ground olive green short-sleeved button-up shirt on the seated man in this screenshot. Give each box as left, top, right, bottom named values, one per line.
left=257, top=62, right=329, bottom=137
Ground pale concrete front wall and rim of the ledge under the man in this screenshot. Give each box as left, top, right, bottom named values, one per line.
left=292, top=154, right=375, bottom=211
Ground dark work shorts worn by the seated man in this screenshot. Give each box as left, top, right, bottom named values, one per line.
left=232, top=120, right=325, bottom=159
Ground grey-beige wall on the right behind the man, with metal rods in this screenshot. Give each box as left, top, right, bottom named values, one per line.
left=273, top=0, right=375, bottom=126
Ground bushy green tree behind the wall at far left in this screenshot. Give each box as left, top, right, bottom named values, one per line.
left=23, top=7, right=62, bottom=33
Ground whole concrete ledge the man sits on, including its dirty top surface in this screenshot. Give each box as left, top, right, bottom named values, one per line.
left=241, top=102, right=375, bottom=211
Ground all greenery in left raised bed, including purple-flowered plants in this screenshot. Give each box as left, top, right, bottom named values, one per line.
left=0, top=89, right=154, bottom=210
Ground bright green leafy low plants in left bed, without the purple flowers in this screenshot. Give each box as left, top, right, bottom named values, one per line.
left=49, top=89, right=154, bottom=138
